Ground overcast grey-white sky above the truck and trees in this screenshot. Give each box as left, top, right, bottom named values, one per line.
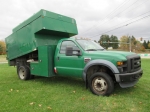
left=0, top=0, right=150, bottom=40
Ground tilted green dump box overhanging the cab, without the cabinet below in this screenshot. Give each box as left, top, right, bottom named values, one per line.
left=5, top=10, right=78, bottom=60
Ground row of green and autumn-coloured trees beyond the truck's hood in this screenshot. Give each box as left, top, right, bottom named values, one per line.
left=98, top=35, right=146, bottom=52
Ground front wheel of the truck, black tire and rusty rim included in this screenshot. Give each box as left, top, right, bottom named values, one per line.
left=88, top=72, right=114, bottom=96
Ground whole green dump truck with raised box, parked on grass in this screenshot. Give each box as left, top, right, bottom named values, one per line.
left=5, top=10, right=143, bottom=95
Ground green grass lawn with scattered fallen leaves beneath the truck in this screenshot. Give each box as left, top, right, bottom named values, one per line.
left=0, top=59, right=150, bottom=112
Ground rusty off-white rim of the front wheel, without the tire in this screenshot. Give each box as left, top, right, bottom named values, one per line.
left=92, top=77, right=108, bottom=94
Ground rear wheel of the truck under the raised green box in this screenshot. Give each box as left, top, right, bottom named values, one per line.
left=18, top=66, right=30, bottom=80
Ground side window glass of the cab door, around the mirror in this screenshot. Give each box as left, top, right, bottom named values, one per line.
left=60, top=41, right=79, bottom=54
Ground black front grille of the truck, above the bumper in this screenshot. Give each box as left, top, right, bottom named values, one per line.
left=127, top=54, right=141, bottom=73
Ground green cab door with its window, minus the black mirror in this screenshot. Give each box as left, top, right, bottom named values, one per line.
left=55, top=40, right=83, bottom=77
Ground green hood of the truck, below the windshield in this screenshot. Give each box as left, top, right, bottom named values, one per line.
left=86, top=51, right=135, bottom=61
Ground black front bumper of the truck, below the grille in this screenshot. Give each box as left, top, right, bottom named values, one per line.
left=115, top=69, right=143, bottom=88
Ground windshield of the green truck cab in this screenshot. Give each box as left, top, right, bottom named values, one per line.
left=76, top=39, right=104, bottom=51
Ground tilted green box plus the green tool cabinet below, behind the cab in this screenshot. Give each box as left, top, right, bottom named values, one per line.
left=5, top=10, right=78, bottom=77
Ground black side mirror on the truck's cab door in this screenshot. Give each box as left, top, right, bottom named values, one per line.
left=66, top=47, right=81, bottom=56
